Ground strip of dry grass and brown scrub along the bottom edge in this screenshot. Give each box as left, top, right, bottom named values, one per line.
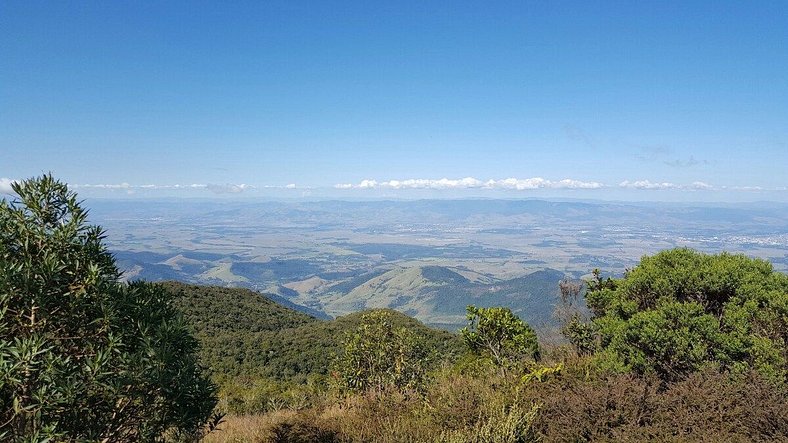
left=206, top=368, right=788, bottom=443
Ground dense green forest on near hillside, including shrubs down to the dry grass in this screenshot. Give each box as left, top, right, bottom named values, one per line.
left=166, top=282, right=462, bottom=413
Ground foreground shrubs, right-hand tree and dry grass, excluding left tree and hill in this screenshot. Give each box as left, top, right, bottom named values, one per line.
left=194, top=249, right=788, bottom=442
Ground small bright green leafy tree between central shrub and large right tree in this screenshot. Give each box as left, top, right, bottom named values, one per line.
left=461, top=305, right=539, bottom=372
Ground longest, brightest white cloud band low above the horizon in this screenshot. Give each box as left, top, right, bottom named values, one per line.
left=334, top=177, right=604, bottom=191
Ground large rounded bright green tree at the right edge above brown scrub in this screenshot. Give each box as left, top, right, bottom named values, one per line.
left=586, top=248, right=788, bottom=382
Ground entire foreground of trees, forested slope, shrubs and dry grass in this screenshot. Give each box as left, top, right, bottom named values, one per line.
left=0, top=176, right=788, bottom=442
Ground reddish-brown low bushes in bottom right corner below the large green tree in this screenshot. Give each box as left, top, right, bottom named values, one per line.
left=523, top=368, right=788, bottom=442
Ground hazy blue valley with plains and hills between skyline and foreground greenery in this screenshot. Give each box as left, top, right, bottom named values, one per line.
left=90, top=199, right=788, bottom=330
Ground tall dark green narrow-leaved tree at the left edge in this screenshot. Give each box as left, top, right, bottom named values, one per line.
left=0, top=175, right=216, bottom=441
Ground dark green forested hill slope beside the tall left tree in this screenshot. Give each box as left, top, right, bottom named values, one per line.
left=165, top=282, right=462, bottom=382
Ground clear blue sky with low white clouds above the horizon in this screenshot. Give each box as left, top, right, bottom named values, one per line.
left=0, top=1, right=788, bottom=201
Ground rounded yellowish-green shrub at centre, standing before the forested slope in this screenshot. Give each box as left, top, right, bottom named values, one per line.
left=335, top=310, right=429, bottom=392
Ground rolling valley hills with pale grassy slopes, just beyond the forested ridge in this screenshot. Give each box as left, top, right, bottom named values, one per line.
left=115, top=248, right=565, bottom=330
